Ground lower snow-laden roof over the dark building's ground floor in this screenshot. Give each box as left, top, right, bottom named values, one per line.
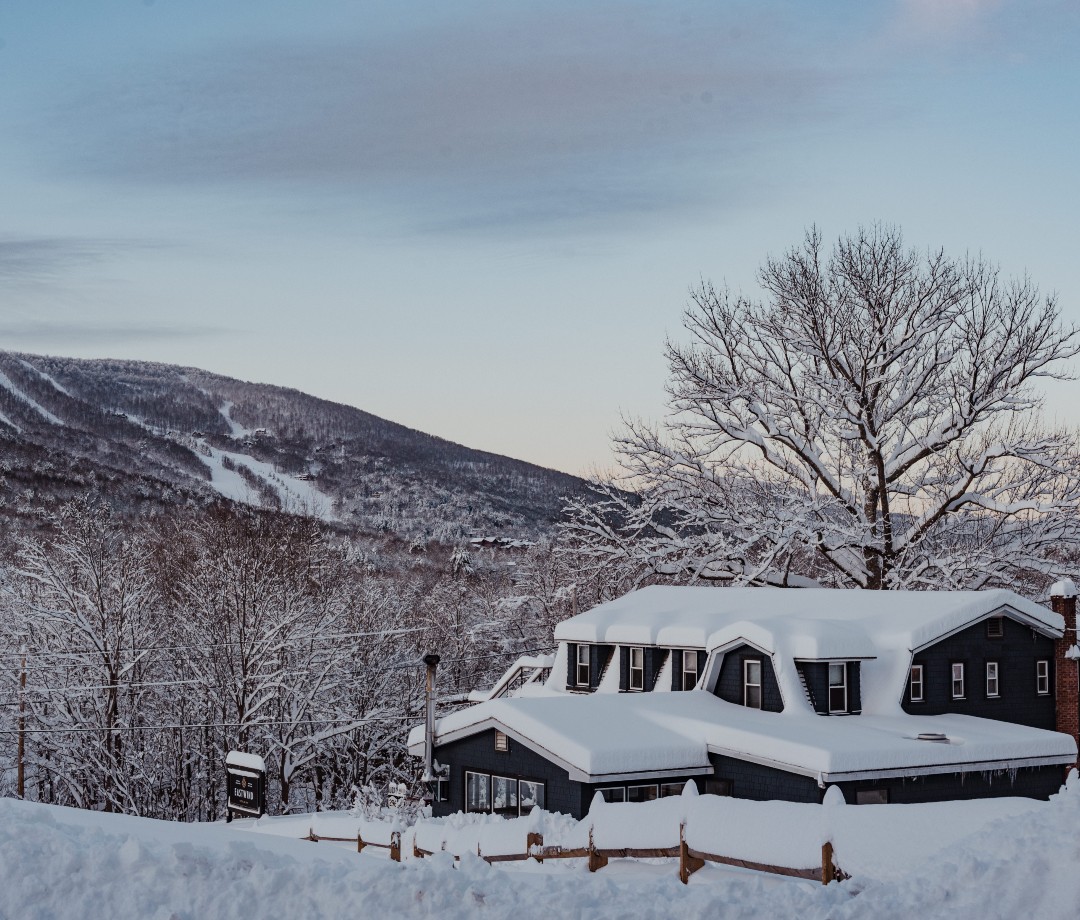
left=409, top=690, right=1077, bottom=783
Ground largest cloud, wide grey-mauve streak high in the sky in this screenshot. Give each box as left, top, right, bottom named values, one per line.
left=41, top=4, right=854, bottom=229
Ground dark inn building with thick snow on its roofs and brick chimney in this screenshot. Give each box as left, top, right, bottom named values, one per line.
left=409, top=581, right=1080, bottom=817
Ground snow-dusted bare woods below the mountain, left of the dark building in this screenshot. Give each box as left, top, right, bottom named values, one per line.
left=0, top=500, right=575, bottom=821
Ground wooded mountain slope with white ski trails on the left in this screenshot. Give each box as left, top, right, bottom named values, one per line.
left=0, top=351, right=586, bottom=542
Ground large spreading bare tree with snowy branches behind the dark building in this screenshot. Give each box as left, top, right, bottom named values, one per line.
left=564, top=227, right=1080, bottom=588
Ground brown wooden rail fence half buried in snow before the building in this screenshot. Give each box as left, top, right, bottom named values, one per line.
left=303, top=824, right=850, bottom=884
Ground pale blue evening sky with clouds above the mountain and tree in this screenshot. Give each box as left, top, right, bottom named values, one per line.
left=0, top=0, right=1080, bottom=473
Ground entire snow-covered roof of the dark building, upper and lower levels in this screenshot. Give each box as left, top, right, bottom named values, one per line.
left=409, top=586, right=1076, bottom=783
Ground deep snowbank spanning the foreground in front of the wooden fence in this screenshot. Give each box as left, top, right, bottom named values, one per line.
left=0, top=781, right=1080, bottom=920
